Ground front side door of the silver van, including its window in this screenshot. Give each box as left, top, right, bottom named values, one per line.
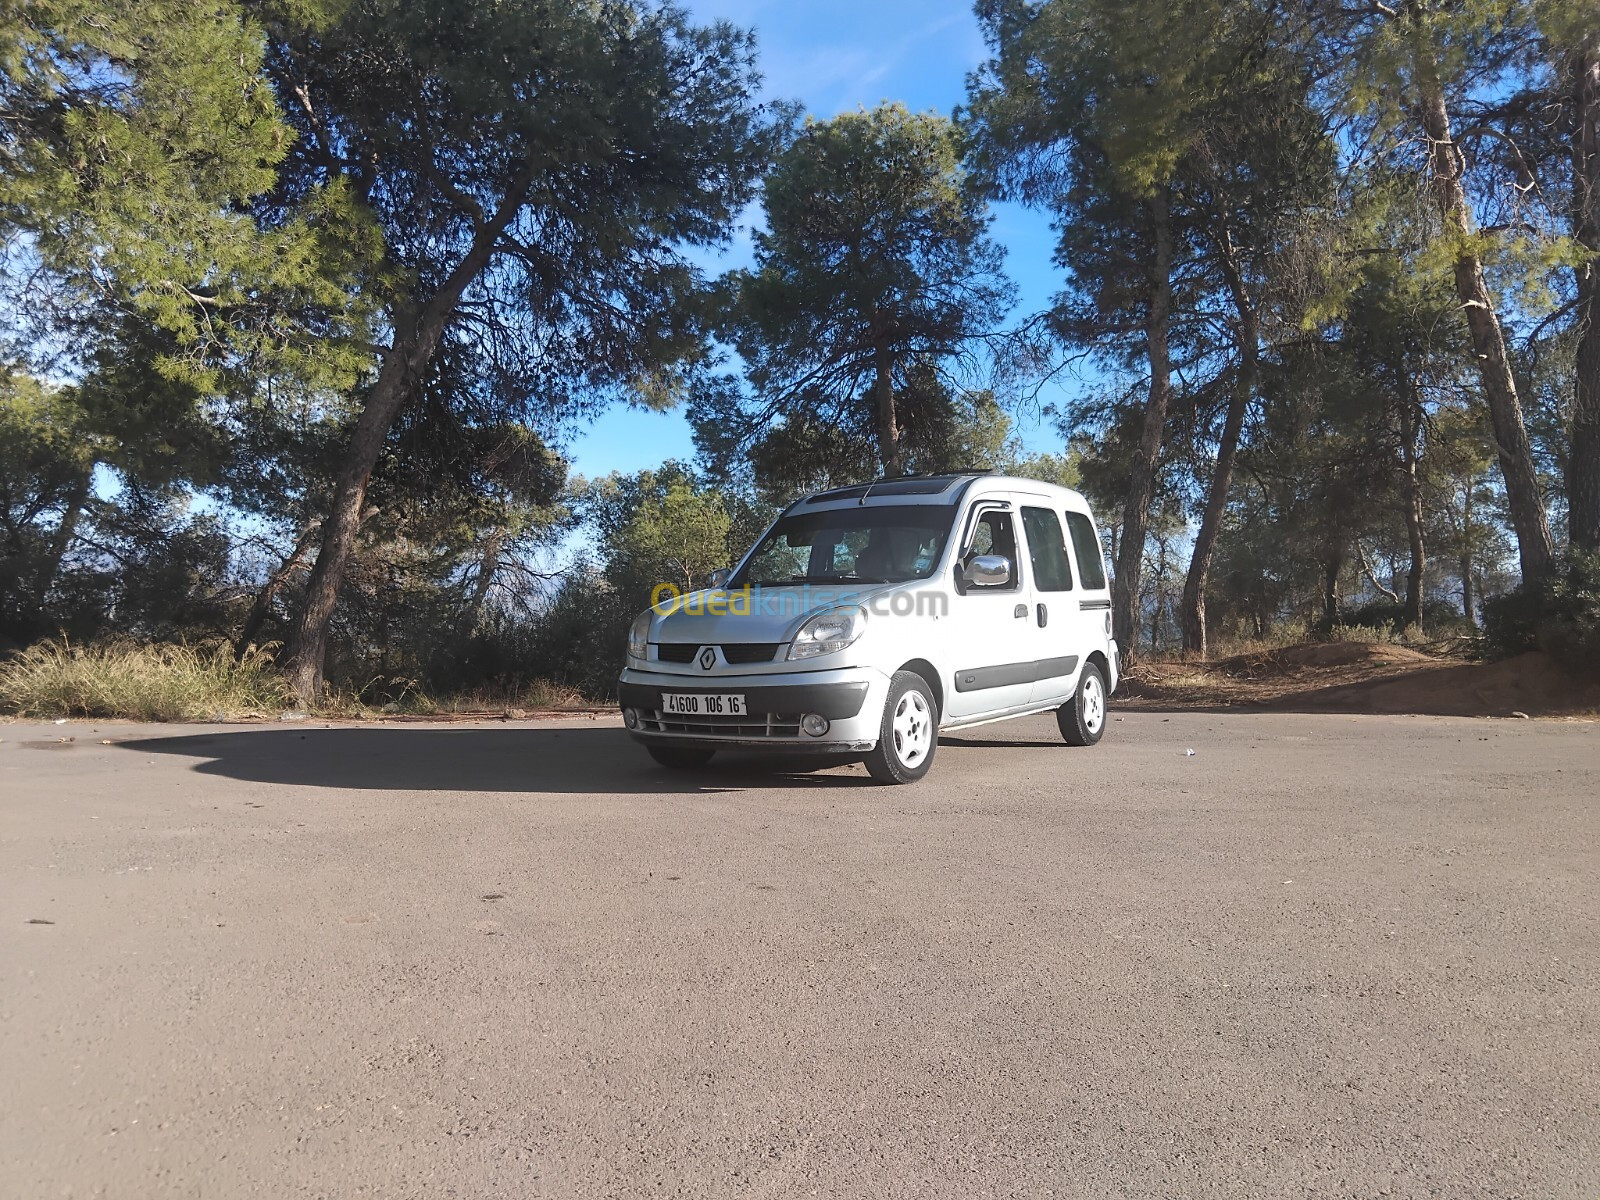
left=944, top=501, right=1034, bottom=720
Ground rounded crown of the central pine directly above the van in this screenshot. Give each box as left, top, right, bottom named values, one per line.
left=699, top=104, right=1011, bottom=475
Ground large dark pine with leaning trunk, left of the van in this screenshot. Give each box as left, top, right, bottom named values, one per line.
left=267, top=0, right=773, bottom=701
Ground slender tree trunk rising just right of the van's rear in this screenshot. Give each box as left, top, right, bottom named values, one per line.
left=1112, top=189, right=1173, bottom=662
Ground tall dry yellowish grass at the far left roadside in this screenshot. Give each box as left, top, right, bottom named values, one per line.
left=0, top=642, right=290, bottom=722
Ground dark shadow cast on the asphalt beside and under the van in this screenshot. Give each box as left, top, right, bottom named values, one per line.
left=117, top=726, right=872, bottom=795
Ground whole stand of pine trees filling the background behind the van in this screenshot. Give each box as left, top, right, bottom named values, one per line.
left=0, top=0, right=1600, bottom=702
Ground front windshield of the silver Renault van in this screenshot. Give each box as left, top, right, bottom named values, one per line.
left=731, top=504, right=955, bottom=587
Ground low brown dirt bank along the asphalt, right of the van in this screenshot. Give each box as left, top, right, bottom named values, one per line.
left=1117, top=642, right=1600, bottom=717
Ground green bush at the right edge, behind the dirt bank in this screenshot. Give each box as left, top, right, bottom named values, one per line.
left=1483, top=550, right=1600, bottom=677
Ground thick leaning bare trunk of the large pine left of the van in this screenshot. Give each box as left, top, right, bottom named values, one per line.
left=285, top=163, right=536, bottom=704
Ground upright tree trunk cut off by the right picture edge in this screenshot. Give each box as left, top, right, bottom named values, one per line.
left=1566, top=35, right=1600, bottom=550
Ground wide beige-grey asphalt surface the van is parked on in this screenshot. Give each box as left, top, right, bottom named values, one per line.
left=0, top=712, right=1600, bottom=1200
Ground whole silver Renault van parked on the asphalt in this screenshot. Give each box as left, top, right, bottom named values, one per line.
left=618, top=474, right=1117, bottom=784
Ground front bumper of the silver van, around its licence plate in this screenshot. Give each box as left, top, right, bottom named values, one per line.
left=616, top=667, right=890, bottom=754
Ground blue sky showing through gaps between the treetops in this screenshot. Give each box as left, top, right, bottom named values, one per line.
left=556, top=0, right=1061, bottom=477
